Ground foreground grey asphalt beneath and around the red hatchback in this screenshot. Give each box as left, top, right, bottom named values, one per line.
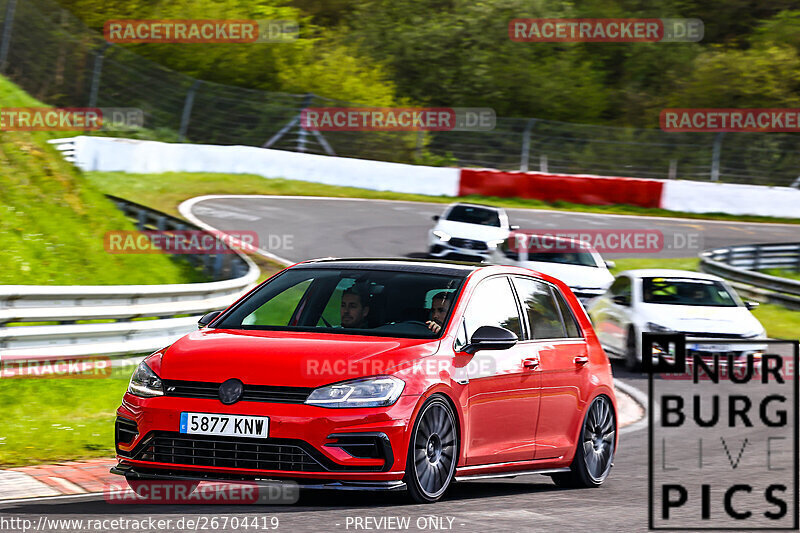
left=0, top=363, right=647, bottom=533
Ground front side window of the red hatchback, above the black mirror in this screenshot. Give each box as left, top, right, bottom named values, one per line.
left=464, top=276, right=522, bottom=339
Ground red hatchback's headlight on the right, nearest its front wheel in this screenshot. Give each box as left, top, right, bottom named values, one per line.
left=306, top=376, right=406, bottom=407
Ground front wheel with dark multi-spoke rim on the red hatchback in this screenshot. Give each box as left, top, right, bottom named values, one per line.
left=404, top=396, right=459, bottom=503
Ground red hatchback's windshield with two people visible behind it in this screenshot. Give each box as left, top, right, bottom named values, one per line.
left=215, top=268, right=463, bottom=338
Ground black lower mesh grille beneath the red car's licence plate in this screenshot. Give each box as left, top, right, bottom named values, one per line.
left=132, top=431, right=329, bottom=472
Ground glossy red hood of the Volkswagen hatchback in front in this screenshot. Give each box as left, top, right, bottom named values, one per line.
left=159, top=329, right=439, bottom=387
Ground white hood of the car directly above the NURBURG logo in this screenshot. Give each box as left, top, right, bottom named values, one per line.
left=642, top=304, right=763, bottom=334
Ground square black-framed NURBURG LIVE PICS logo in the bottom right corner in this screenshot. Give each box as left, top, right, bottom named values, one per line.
left=642, top=333, right=798, bottom=531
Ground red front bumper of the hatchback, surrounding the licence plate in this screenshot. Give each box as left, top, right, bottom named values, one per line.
left=115, top=394, right=419, bottom=484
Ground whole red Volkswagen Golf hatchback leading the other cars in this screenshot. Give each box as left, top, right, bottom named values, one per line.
left=112, top=260, right=617, bottom=502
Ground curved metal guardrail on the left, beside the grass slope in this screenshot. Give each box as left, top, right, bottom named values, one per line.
left=0, top=198, right=260, bottom=360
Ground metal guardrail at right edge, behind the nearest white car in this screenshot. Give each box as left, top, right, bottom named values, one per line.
left=700, top=243, right=800, bottom=311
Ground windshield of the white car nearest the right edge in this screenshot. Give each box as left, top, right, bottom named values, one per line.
left=642, top=278, right=738, bottom=307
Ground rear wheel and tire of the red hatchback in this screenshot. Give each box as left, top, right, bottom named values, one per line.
left=552, top=396, right=617, bottom=488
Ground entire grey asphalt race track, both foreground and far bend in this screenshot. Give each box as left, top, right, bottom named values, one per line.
left=0, top=197, right=797, bottom=533
